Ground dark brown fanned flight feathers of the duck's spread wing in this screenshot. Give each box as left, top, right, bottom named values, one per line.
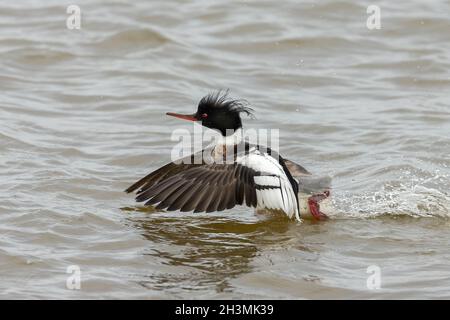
left=126, top=163, right=257, bottom=212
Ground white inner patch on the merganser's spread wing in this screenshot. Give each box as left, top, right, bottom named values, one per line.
left=236, top=149, right=300, bottom=221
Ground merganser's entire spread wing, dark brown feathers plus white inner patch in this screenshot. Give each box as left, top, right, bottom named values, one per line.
left=126, top=143, right=300, bottom=219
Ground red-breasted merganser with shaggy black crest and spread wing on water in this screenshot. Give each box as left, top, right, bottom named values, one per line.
left=126, top=92, right=329, bottom=221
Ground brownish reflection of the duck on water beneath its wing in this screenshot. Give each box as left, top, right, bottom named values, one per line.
left=123, top=208, right=295, bottom=292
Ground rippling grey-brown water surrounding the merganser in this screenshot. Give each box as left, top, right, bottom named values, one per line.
left=0, top=0, right=450, bottom=299
